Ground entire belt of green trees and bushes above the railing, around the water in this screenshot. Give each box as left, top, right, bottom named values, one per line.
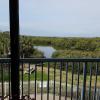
left=0, top=32, right=100, bottom=58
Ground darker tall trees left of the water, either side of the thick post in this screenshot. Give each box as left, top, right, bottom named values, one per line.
left=0, top=32, right=43, bottom=57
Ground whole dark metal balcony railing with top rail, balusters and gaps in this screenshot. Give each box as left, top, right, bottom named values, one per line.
left=0, top=58, right=100, bottom=100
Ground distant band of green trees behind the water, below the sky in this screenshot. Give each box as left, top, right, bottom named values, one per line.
left=28, top=36, right=100, bottom=51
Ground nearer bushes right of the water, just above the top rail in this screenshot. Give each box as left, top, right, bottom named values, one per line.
left=52, top=50, right=100, bottom=58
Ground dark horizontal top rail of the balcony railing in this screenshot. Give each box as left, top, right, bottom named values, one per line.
left=0, top=58, right=100, bottom=63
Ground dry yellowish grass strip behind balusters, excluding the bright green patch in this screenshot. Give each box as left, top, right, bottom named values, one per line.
left=34, top=67, right=100, bottom=87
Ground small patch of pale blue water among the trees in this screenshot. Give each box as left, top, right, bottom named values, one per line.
left=34, top=46, right=56, bottom=58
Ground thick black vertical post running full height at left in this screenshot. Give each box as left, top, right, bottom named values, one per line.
left=9, top=0, right=20, bottom=100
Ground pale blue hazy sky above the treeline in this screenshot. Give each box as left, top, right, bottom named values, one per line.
left=0, top=0, right=100, bottom=37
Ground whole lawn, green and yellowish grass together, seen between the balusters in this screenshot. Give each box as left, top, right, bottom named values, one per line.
left=0, top=67, right=100, bottom=87
